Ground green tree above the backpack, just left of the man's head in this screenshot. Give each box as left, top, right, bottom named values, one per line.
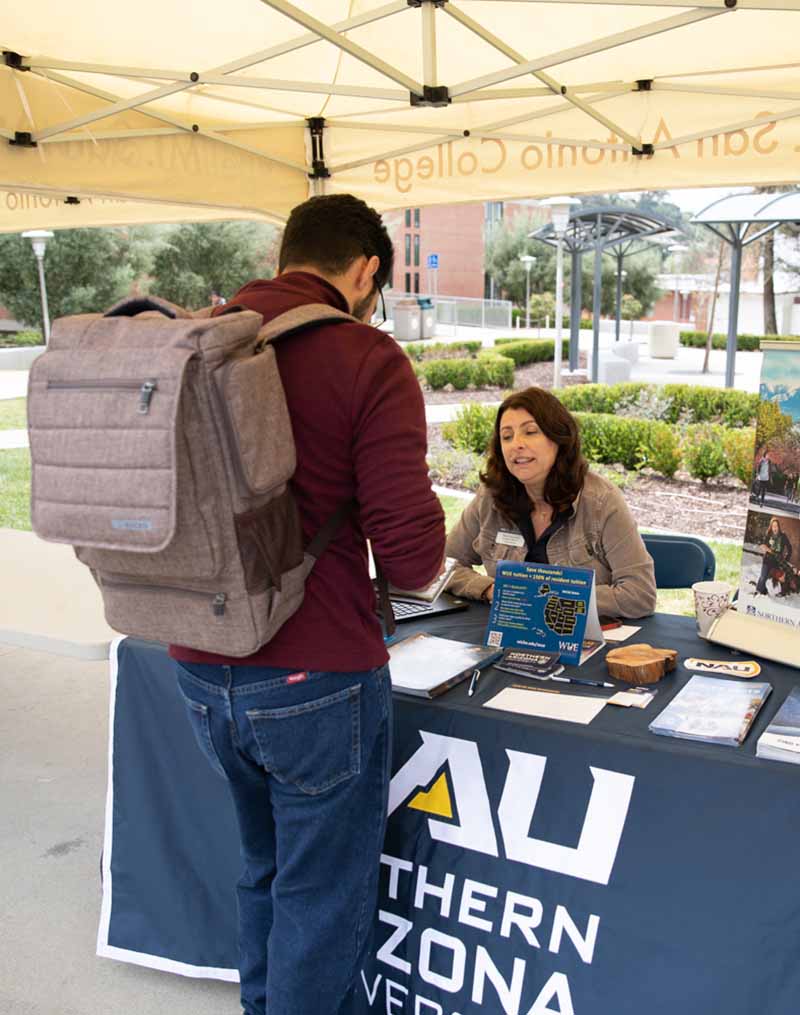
left=150, top=222, right=277, bottom=310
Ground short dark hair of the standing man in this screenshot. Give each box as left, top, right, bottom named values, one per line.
left=278, top=194, right=394, bottom=288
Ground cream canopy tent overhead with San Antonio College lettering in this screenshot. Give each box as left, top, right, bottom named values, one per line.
left=0, top=0, right=800, bottom=227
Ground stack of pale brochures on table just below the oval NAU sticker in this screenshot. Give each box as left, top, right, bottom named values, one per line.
left=650, top=676, right=773, bottom=747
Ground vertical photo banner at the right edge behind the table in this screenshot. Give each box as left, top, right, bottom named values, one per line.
left=739, top=342, right=800, bottom=628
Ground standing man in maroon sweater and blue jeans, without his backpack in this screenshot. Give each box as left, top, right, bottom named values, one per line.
left=170, top=195, right=445, bottom=1015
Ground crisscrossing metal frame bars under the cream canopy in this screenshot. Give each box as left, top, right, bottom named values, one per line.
left=0, top=0, right=800, bottom=188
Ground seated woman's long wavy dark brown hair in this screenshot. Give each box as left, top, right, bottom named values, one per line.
left=480, top=388, right=589, bottom=521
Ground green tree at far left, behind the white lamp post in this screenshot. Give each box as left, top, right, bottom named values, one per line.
left=0, top=229, right=147, bottom=329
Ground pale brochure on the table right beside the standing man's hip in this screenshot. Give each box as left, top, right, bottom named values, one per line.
left=389, top=632, right=502, bottom=698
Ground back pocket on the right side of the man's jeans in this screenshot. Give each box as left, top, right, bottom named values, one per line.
left=247, top=684, right=361, bottom=796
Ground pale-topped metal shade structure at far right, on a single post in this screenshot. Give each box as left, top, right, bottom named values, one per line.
left=692, top=191, right=800, bottom=388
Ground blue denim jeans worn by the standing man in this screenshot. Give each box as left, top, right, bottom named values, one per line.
left=176, top=664, right=392, bottom=1015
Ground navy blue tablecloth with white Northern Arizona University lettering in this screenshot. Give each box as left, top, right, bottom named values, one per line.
left=98, top=607, right=800, bottom=1015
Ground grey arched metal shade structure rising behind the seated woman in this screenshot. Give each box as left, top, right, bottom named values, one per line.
left=530, top=205, right=676, bottom=383
